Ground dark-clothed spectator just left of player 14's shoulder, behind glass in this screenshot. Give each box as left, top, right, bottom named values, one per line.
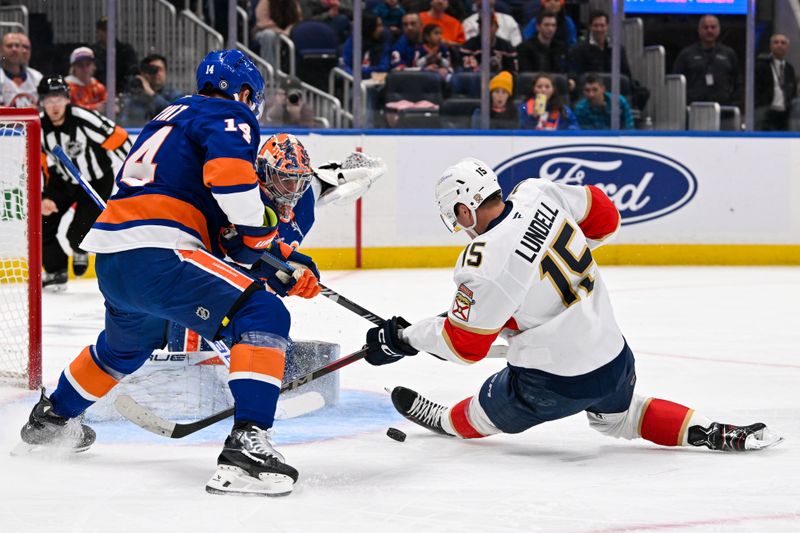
left=120, top=54, right=183, bottom=126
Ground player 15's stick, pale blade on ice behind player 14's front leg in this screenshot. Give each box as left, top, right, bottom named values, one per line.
left=114, top=348, right=367, bottom=439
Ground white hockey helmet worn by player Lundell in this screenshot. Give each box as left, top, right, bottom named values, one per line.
left=436, top=157, right=500, bottom=232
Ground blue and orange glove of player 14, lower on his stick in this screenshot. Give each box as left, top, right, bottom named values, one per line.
left=251, top=242, right=322, bottom=298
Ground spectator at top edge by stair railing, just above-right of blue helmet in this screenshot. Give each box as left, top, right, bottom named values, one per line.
left=253, top=0, right=303, bottom=70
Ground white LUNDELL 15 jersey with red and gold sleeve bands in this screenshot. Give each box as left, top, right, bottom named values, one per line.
left=403, top=179, right=624, bottom=376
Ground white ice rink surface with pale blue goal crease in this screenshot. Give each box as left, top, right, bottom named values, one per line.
left=0, top=268, right=800, bottom=533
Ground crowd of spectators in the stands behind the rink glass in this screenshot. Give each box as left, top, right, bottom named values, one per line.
left=0, top=0, right=797, bottom=130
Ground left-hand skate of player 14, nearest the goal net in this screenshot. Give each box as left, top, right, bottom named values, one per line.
left=12, top=388, right=96, bottom=455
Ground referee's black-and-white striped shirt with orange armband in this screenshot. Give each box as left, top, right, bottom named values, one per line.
left=39, top=105, right=131, bottom=186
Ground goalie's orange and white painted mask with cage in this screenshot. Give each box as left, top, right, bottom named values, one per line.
left=257, top=133, right=314, bottom=222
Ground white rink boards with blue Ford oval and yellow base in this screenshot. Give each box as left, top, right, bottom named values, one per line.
left=290, top=132, right=800, bottom=268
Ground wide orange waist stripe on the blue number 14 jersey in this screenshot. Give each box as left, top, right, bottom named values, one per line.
left=97, top=194, right=211, bottom=250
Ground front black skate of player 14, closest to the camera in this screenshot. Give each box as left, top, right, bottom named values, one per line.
left=206, top=423, right=298, bottom=496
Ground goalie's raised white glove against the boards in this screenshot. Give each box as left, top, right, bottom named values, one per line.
left=314, top=152, right=386, bottom=205
